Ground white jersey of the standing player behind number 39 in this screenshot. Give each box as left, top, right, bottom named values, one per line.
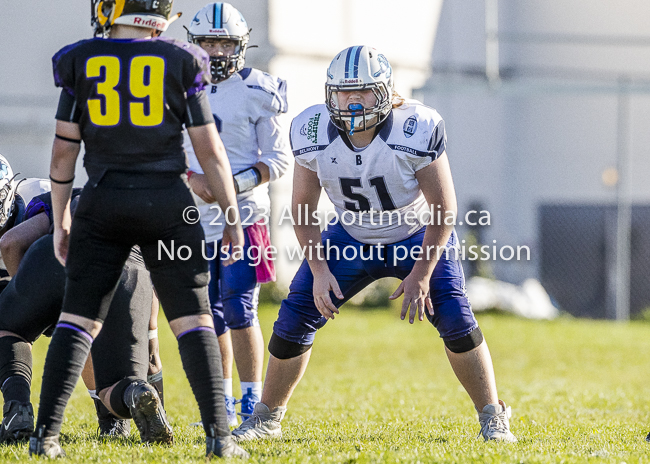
left=185, top=68, right=291, bottom=241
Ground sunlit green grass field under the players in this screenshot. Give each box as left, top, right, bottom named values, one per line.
left=0, top=307, right=650, bottom=463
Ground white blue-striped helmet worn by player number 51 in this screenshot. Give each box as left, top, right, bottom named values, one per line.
left=325, top=45, right=393, bottom=134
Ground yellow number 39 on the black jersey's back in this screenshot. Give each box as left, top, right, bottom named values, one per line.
left=86, top=56, right=165, bottom=127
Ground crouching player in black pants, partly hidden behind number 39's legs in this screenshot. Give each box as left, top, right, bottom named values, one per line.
left=0, top=189, right=165, bottom=443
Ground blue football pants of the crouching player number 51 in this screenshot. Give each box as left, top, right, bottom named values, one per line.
left=273, top=224, right=478, bottom=345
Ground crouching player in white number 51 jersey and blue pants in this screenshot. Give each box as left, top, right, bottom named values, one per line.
left=233, top=46, right=516, bottom=442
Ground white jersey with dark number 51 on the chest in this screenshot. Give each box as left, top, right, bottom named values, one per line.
left=291, top=100, right=447, bottom=245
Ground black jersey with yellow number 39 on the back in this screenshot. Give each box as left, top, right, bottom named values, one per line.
left=52, top=38, right=214, bottom=174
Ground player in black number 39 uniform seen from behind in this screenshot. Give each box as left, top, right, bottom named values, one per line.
left=29, top=0, right=248, bottom=458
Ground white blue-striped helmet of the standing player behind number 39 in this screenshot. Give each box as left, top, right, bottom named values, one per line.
left=187, top=2, right=250, bottom=81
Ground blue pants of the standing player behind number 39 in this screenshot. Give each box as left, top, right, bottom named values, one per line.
left=206, top=231, right=260, bottom=337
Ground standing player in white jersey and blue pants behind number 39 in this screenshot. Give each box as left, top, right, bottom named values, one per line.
left=185, top=3, right=290, bottom=426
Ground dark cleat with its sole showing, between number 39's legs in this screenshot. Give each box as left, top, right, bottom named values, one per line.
left=125, top=382, right=174, bottom=445
